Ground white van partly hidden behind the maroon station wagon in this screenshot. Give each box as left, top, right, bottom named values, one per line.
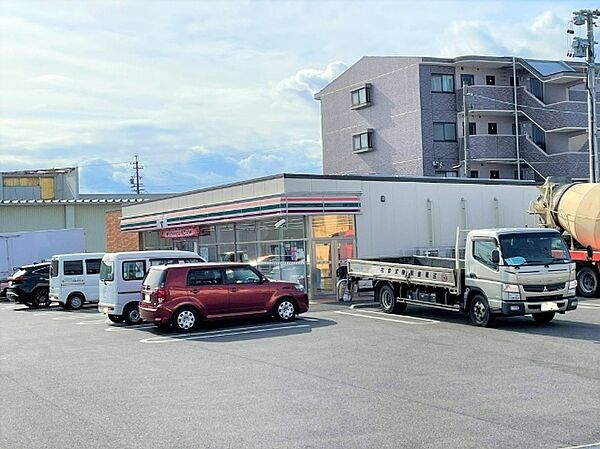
left=98, top=250, right=205, bottom=324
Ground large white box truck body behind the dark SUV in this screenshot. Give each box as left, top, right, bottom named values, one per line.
left=0, top=229, right=85, bottom=295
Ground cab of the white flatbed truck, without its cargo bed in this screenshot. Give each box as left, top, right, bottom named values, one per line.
left=464, top=228, right=577, bottom=326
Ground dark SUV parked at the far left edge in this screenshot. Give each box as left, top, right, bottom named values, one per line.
left=6, top=263, right=50, bottom=308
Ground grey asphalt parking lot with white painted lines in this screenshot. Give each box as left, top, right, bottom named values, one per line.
left=0, top=300, right=600, bottom=449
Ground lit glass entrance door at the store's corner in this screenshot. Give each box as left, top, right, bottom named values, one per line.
left=311, top=239, right=354, bottom=296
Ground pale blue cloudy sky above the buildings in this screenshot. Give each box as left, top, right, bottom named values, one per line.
left=0, top=0, right=594, bottom=193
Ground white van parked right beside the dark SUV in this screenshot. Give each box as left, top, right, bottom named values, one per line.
left=49, top=253, right=104, bottom=309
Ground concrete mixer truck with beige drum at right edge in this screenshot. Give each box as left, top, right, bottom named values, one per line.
left=530, top=179, right=600, bottom=298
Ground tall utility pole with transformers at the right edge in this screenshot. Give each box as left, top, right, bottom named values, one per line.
left=567, top=9, right=600, bottom=182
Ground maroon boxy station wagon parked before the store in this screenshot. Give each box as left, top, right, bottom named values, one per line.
left=139, top=263, right=308, bottom=332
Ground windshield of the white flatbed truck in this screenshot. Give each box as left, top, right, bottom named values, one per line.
left=499, top=232, right=571, bottom=266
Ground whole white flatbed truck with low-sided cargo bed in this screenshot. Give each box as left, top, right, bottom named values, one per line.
left=345, top=228, right=577, bottom=327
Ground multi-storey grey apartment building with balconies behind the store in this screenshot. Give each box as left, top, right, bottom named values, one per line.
left=315, top=56, right=589, bottom=179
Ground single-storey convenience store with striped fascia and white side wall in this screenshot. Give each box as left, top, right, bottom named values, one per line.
left=121, top=174, right=538, bottom=296
